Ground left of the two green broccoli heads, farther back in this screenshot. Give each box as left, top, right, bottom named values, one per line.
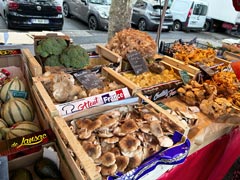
left=36, top=37, right=67, bottom=58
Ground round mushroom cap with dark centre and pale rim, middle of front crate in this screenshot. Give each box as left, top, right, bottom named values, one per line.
left=119, top=134, right=141, bottom=152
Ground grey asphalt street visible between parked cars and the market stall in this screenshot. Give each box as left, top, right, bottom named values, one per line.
left=0, top=14, right=237, bottom=49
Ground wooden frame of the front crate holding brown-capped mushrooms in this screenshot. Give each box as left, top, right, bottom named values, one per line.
left=48, top=93, right=189, bottom=180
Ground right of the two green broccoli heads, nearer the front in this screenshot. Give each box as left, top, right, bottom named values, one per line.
left=60, top=45, right=89, bottom=68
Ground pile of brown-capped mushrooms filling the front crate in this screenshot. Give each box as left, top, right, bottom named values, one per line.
left=69, top=105, right=181, bottom=177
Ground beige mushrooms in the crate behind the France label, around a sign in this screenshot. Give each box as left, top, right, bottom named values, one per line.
left=42, top=71, right=124, bottom=103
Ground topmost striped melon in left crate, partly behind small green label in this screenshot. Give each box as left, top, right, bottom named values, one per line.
left=0, top=76, right=26, bottom=102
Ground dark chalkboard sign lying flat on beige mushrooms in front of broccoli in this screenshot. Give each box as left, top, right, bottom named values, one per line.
left=73, top=70, right=103, bottom=90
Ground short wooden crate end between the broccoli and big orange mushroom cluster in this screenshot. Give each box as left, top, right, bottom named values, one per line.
left=96, top=45, right=122, bottom=63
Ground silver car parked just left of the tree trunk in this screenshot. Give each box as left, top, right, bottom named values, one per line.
left=63, top=0, right=111, bottom=30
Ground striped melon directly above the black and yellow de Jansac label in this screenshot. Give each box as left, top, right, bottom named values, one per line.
left=4, top=121, right=41, bottom=139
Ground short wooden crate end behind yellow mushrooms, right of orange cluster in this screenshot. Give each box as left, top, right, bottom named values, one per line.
left=161, top=56, right=200, bottom=76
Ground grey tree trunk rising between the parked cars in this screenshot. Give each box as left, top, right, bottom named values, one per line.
left=108, top=0, right=136, bottom=41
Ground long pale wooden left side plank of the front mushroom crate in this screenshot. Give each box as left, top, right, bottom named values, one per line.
left=54, top=117, right=102, bottom=180
